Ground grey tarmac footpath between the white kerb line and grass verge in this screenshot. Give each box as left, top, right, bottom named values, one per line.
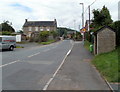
left=47, top=42, right=110, bottom=90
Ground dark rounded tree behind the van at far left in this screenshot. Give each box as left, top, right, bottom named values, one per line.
left=1, top=21, right=15, bottom=32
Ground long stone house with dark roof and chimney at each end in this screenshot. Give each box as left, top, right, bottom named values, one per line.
left=23, top=19, right=57, bottom=37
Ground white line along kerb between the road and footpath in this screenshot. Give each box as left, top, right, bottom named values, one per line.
left=43, top=40, right=74, bottom=90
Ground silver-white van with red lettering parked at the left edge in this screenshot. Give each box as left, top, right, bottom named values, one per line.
left=0, top=35, right=16, bottom=51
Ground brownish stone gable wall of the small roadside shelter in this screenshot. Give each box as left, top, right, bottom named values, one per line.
left=97, top=28, right=116, bottom=54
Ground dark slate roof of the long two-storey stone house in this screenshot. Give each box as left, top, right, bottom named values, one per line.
left=23, top=21, right=56, bottom=27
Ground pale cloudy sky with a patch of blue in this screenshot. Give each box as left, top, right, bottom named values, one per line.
left=0, top=0, right=120, bottom=31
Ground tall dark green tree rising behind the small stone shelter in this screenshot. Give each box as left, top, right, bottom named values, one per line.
left=93, top=6, right=113, bottom=27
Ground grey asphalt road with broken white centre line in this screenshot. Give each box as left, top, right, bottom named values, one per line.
left=0, top=40, right=72, bottom=90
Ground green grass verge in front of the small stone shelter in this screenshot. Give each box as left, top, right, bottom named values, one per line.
left=92, top=47, right=120, bottom=83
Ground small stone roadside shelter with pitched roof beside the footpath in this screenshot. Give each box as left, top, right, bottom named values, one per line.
left=94, top=26, right=116, bottom=54
